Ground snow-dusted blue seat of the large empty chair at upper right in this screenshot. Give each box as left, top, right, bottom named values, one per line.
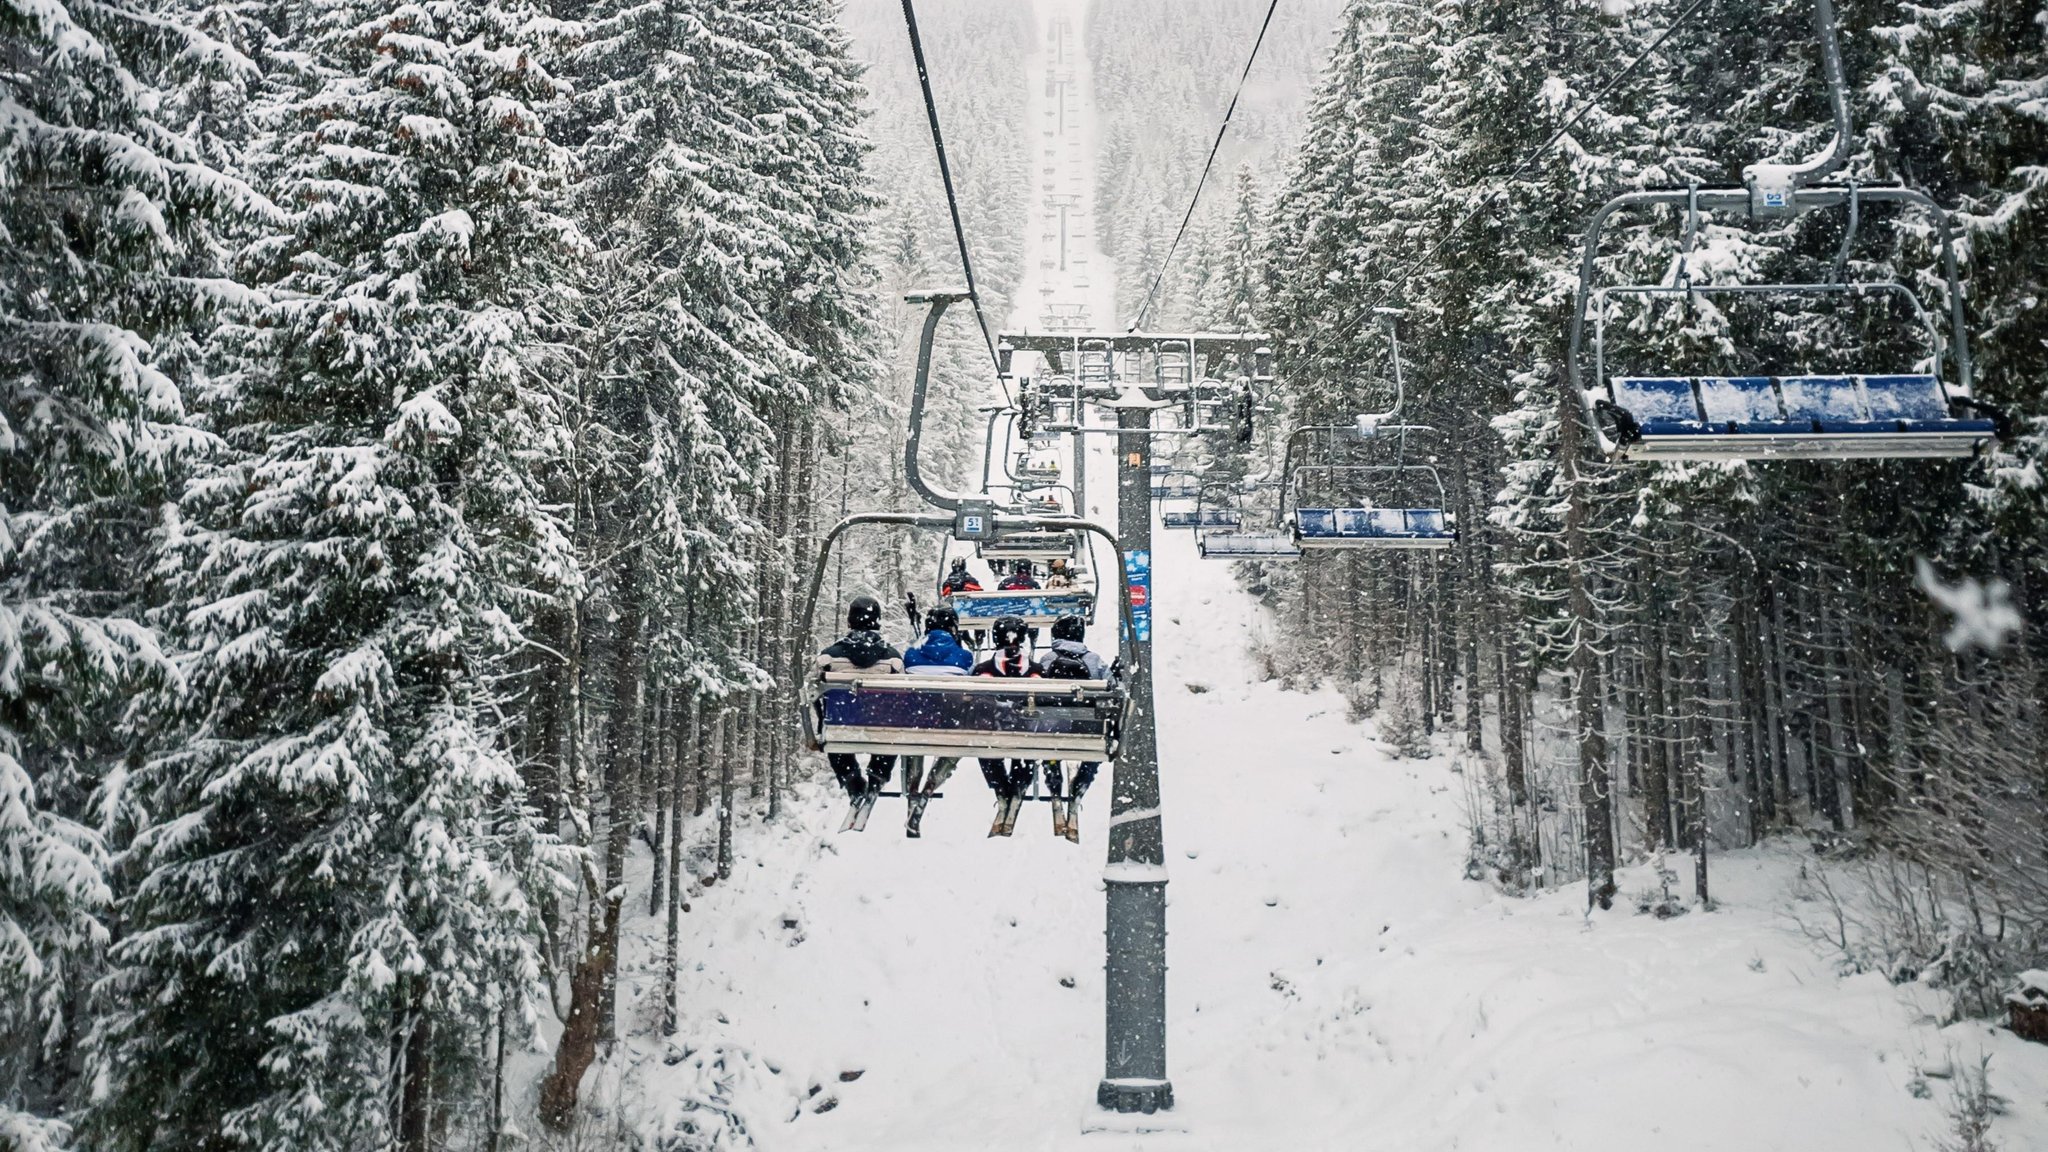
left=1610, top=375, right=1997, bottom=459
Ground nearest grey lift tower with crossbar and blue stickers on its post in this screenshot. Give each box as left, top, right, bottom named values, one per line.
left=995, top=332, right=1272, bottom=1113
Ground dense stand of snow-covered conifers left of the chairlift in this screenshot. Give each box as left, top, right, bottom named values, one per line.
left=0, top=0, right=879, bottom=1152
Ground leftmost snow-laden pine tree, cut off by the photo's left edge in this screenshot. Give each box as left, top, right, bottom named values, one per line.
left=0, top=2, right=270, bottom=1148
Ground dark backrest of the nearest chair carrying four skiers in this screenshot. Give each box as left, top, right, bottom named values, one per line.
left=813, top=672, right=1124, bottom=760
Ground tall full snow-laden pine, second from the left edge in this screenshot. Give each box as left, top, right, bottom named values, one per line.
left=88, top=0, right=571, bottom=1150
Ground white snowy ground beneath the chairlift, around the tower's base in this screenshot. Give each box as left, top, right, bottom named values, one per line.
left=594, top=522, right=2048, bottom=1152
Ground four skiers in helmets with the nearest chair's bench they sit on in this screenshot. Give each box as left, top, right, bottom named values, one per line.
left=817, top=596, right=1122, bottom=842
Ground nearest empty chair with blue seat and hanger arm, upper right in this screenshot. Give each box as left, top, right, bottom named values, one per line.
left=1565, top=0, right=2011, bottom=459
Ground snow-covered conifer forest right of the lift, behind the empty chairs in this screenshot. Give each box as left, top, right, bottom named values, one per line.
left=1251, top=0, right=2048, bottom=1013
